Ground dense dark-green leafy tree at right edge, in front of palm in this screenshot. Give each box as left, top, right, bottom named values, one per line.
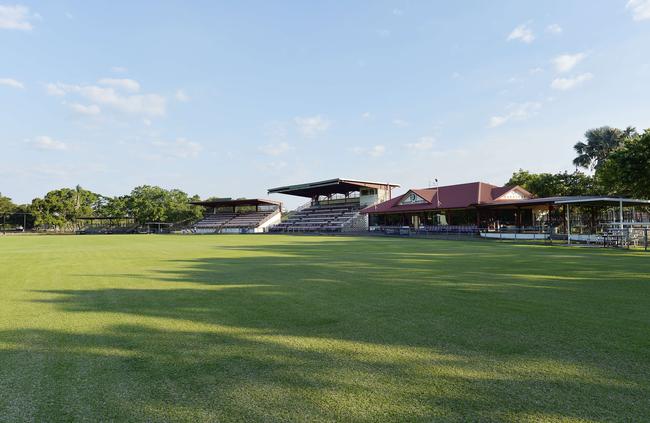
left=596, top=130, right=650, bottom=199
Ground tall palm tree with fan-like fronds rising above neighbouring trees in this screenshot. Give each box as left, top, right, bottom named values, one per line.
left=573, top=126, right=638, bottom=170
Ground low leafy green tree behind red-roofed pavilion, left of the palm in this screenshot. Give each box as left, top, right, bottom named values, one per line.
left=506, top=169, right=601, bottom=197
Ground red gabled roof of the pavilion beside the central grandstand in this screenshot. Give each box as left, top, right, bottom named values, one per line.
left=361, top=182, right=532, bottom=213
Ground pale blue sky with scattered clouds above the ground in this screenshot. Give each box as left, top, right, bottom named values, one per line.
left=0, top=0, right=650, bottom=206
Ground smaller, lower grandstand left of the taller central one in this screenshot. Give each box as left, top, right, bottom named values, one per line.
left=187, top=198, right=282, bottom=233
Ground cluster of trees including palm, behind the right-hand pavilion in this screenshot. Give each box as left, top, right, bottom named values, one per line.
left=506, top=126, right=650, bottom=199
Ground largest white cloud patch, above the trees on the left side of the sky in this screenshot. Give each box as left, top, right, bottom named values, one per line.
left=46, top=80, right=166, bottom=117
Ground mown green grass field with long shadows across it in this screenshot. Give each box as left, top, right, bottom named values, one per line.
left=0, top=235, right=650, bottom=422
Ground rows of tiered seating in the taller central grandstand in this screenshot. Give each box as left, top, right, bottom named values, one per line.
left=271, top=204, right=359, bottom=232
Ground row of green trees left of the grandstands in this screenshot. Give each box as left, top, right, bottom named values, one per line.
left=0, top=185, right=203, bottom=231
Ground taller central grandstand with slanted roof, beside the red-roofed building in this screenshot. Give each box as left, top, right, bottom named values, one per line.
left=268, top=178, right=399, bottom=232
